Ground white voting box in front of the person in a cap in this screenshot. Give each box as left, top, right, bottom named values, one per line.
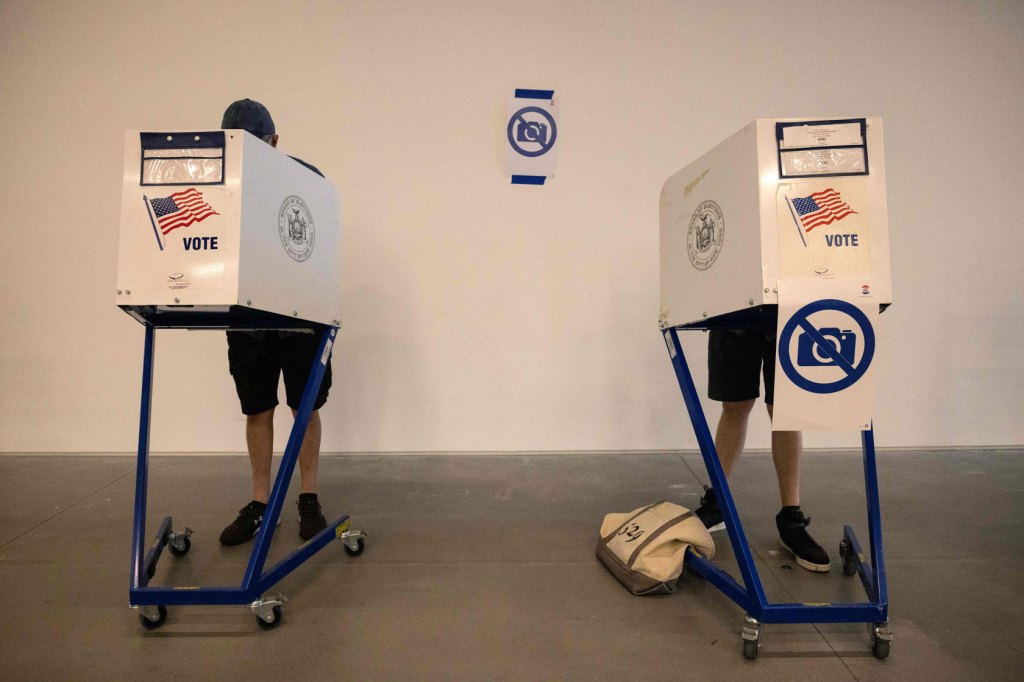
left=117, top=130, right=341, bottom=326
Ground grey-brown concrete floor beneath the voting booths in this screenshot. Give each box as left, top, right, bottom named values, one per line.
left=0, top=451, right=1024, bottom=681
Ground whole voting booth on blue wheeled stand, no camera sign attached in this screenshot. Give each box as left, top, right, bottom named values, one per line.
left=116, top=130, right=365, bottom=629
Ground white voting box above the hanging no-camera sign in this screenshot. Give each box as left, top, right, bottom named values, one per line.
left=659, top=118, right=892, bottom=328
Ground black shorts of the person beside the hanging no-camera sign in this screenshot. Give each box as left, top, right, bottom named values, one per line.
left=708, top=329, right=775, bottom=404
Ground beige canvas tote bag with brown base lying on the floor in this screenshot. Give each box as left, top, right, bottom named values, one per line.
left=597, top=502, right=715, bottom=595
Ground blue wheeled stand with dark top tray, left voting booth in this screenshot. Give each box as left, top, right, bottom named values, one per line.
left=121, top=305, right=366, bottom=630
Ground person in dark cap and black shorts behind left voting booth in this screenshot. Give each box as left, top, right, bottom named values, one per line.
left=220, top=99, right=331, bottom=545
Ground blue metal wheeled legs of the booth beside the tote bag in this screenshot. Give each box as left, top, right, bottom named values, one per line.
left=664, top=329, right=892, bottom=658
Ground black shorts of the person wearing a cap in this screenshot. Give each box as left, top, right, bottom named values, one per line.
left=227, top=331, right=331, bottom=415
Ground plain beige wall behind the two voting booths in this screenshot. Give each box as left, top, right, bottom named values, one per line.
left=0, top=0, right=1024, bottom=452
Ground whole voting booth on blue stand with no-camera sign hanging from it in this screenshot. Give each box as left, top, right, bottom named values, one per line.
left=658, top=117, right=892, bottom=658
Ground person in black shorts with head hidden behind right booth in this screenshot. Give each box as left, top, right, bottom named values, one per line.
left=696, top=329, right=831, bottom=571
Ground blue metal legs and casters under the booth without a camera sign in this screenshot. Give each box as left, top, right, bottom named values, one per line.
left=129, top=325, right=366, bottom=629
